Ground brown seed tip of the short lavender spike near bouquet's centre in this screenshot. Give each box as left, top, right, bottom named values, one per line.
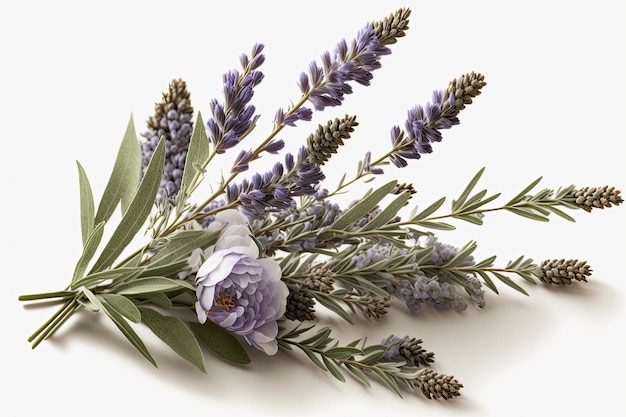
left=307, top=115, right=358, bottom=165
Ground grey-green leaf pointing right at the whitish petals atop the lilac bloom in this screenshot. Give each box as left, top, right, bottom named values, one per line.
left=147, top=229, right=221, bottom=266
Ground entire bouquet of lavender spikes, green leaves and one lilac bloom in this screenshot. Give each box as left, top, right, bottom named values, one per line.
left=19, top=8, right=623, bottom=400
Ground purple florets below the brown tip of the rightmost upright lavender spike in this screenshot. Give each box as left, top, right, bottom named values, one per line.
left=389, top=90, right=459, bottom=168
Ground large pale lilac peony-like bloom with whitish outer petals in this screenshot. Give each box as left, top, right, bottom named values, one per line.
left=196, top=210, right=289, bottom=355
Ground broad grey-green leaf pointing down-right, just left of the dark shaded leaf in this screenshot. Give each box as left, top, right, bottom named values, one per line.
left=139, top=307, right=206, bottom=373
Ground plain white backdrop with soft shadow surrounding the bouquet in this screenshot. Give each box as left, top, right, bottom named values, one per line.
left=0, top=0, right=626, bottom=417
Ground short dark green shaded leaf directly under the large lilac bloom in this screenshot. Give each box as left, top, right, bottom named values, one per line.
left=188, top=320, right=250, bottom=365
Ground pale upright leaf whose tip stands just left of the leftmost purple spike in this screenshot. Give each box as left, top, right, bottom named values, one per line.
left=95, top=115, right=141, bottom=223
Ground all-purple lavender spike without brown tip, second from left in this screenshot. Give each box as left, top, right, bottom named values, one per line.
left=206, top=44, right=265, bottom=154
